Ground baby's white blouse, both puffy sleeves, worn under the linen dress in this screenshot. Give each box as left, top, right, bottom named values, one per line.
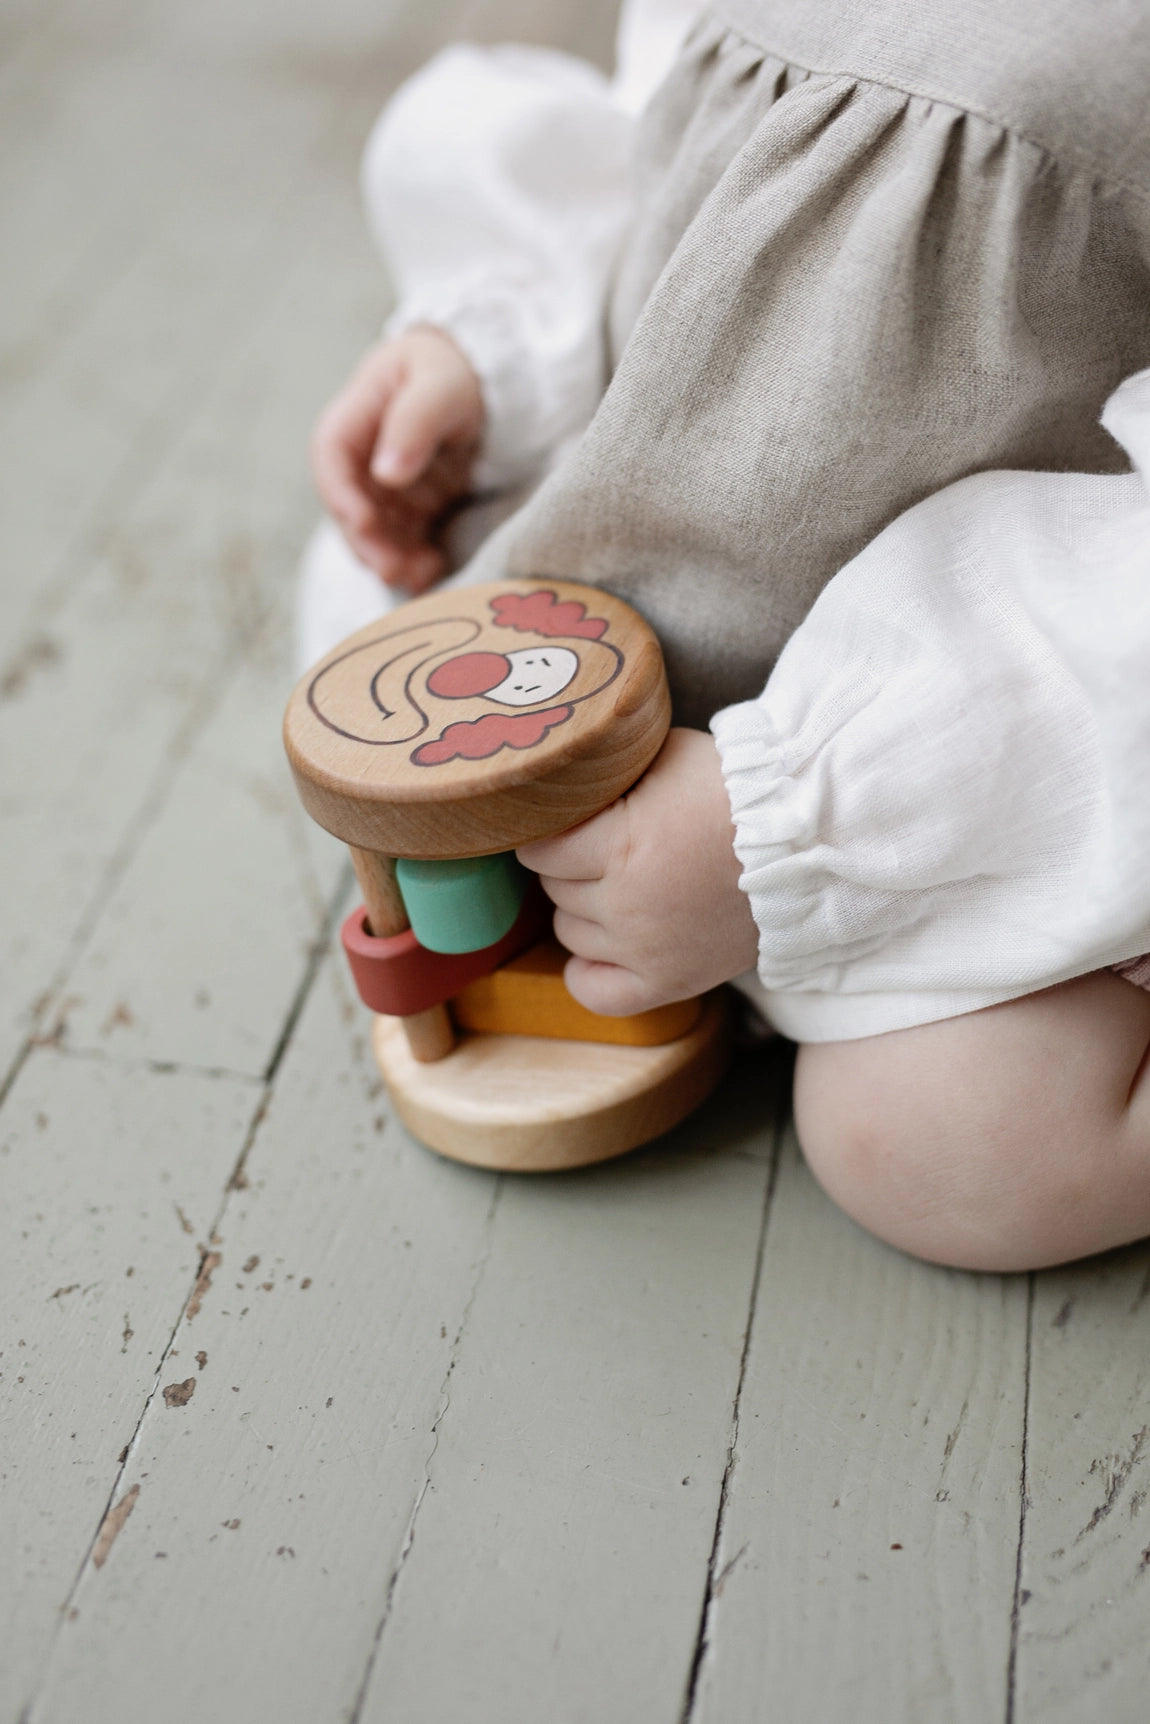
left=351, top=0, right=1150, bottom=1041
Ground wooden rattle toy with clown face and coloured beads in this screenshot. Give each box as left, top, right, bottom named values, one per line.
left=284, top=581, right=728, bottom=1171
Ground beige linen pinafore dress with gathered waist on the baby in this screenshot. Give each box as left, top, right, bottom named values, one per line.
left=467, top=0, right=1150, bottom=724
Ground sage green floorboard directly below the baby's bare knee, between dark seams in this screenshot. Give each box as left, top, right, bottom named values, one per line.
left=691, top=1140, right=1026, bottom=1724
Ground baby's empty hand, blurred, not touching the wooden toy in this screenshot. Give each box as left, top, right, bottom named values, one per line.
left=312, top=329, right=483, bottom=593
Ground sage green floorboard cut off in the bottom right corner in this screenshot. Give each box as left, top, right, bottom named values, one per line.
left=1014, top=1245, right=1150, bottom=1724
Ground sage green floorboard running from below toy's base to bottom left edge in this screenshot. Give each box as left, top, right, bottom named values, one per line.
left=29, top=965, right=500, bottom=1724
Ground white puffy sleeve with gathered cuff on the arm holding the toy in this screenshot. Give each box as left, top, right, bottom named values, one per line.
left=712, top=371, right=1150, bottom=1041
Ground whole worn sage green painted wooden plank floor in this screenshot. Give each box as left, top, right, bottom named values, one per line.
left=0, top=0, right=1150, bottom=1724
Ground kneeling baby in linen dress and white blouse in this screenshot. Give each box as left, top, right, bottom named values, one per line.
left=301, top=0, right=1150, bottom=1269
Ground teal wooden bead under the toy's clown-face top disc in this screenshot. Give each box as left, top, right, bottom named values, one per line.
left=395, top=850, right=528, bottom=952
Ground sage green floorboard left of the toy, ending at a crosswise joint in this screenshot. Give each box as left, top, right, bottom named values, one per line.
left=51, top=620, right=347, bottom=1076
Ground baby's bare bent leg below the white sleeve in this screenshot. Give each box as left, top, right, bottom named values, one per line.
left=795, top=971, right=1150, bottom=1271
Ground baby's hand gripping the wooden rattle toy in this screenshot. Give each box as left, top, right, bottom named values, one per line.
left=517, top=729, right=759, bottom=1017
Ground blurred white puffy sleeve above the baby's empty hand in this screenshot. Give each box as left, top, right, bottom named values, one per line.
left=362, top=0, right=698, bottom=488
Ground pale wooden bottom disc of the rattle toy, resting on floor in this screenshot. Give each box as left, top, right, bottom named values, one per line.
left=372, top=991, right=729, bottom=1172
